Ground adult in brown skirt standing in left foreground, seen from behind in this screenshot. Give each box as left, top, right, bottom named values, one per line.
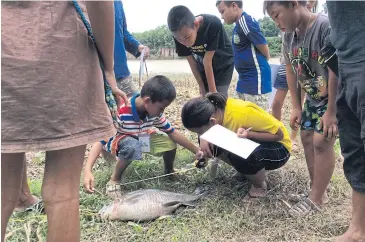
left=1, top=1, right=121, bottom=241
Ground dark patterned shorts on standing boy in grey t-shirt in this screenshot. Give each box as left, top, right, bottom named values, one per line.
left=301, top=100, right=327, bottom=134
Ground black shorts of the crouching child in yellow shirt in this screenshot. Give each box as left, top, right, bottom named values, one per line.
left=214, top=142, right=290, bottom=175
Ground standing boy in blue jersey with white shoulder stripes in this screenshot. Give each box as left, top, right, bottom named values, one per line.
left=216, top=1, right=272, bottom=110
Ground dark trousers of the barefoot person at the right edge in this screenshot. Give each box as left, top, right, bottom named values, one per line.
left=337, top=61, right=365, bottom=194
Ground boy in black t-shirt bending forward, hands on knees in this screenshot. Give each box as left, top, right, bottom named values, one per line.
left=167, top=6, right=234, bottom=96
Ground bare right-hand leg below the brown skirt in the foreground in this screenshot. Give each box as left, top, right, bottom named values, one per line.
left=42, top=145, right=86, bottom=242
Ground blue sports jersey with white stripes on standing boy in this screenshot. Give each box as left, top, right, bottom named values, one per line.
left=232, top=12, right=272, bottom=95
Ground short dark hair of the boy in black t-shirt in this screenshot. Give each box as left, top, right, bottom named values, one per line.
left=167, top=5, right=195, bottom=32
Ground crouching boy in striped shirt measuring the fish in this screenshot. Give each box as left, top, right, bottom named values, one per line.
left=84, top=76, right=202, bottom=198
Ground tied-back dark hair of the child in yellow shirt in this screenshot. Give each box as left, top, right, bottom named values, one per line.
left=181, top=93, right=227, bottom=129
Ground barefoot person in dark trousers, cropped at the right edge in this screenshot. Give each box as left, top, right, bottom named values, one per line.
left=327, top=1, right=365, bottom=242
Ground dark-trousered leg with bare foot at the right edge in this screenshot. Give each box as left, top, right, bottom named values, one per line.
left=337, top=62, right=365, bottom=242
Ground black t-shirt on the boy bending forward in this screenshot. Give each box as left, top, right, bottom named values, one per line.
left=174, top=14, right=234, bottom=85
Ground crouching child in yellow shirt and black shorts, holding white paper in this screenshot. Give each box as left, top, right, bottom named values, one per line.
left=181, top=93, right=291, bottom=198
